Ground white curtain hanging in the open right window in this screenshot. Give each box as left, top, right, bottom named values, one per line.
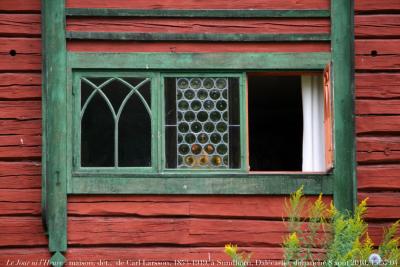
left=301, top=75, right=326, bottom=172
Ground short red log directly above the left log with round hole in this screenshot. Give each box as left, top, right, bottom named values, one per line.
left=0, top=14, right=40, bottom=37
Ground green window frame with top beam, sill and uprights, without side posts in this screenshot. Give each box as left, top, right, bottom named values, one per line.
left=67, top=52, right=335, bottom=194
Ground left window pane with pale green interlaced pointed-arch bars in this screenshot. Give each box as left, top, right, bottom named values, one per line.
left=80, top=77, right=151, bottom=168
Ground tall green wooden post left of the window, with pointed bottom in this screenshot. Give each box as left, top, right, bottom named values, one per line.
left=42, top=0, right=67, bottom=266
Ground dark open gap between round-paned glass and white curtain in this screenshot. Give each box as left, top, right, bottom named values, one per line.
left=248, top=75, right=303, bottom=171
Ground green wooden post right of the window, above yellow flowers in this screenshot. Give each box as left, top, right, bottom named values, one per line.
left=331, top=0, right=357, bottom=214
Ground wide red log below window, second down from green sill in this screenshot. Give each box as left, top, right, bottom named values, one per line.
left=68, top=216, right=310, bottom=247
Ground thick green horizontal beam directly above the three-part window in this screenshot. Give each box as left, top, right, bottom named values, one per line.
left=68, top=53, right=331, bottom=71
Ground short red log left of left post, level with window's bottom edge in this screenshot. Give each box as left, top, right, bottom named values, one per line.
left=0, top=161, right=41, bottom=189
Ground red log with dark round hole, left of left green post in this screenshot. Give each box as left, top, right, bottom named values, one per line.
left=0, top=38, right=41, bottom=71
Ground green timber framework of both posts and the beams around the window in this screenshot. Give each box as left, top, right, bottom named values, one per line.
left=41, top=0, right=357, bottom=266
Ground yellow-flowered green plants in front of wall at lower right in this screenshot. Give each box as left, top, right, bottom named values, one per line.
left=283, top=187, right=400, bottom=266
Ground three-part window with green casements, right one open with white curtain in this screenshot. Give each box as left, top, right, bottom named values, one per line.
left=73, top=70, right=330, bottom=174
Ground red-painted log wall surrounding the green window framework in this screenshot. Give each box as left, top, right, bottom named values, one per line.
left=0, top=0, right=400, bottom=266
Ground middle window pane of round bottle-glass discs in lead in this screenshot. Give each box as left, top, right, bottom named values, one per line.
left=164, top=77, right=240, bottom=169
